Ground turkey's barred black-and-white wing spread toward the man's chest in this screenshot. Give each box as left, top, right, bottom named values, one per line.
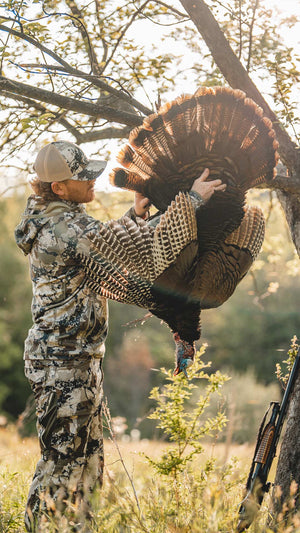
left=76, top=193, right=197, bottom=310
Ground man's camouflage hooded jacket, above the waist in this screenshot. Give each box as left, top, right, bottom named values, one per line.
left=15, top=195, right=128, bottom=360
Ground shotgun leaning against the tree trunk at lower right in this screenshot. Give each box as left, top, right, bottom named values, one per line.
left=236, top=350, right=300, bottom=533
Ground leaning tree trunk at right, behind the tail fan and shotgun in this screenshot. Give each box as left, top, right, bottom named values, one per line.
left=180, top=0, right=300, bottom=511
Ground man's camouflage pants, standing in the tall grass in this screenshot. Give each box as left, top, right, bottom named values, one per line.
left=25, top=359, right=103, bottom=531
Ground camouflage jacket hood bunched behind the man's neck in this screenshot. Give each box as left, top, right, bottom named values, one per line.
left=15, top=195, right=84, bottom=255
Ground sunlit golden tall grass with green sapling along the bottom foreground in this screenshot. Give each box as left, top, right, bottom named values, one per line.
left=0, top=348, right=300, bottom=533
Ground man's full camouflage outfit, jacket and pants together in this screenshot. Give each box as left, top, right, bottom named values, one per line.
left=15, top=196, right=119, bottom=531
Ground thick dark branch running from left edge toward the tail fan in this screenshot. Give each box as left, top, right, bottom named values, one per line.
left=0, top=76, right=143, bottom=126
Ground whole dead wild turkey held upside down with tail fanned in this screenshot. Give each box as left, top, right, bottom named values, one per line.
left=77, top=87, right=278, bottom=374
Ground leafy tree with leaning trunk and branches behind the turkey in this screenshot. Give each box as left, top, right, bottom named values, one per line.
left=0, top=0, right=300, bottom=516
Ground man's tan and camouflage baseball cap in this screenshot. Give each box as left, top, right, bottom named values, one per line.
left=33, top=141, right=106, bottom=183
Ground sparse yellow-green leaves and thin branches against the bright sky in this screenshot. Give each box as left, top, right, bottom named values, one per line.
left=0, top=0, right=299, bottom=165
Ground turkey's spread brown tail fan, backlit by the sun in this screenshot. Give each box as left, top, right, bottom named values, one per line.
left=110, top=87, right=278, bottom=211
